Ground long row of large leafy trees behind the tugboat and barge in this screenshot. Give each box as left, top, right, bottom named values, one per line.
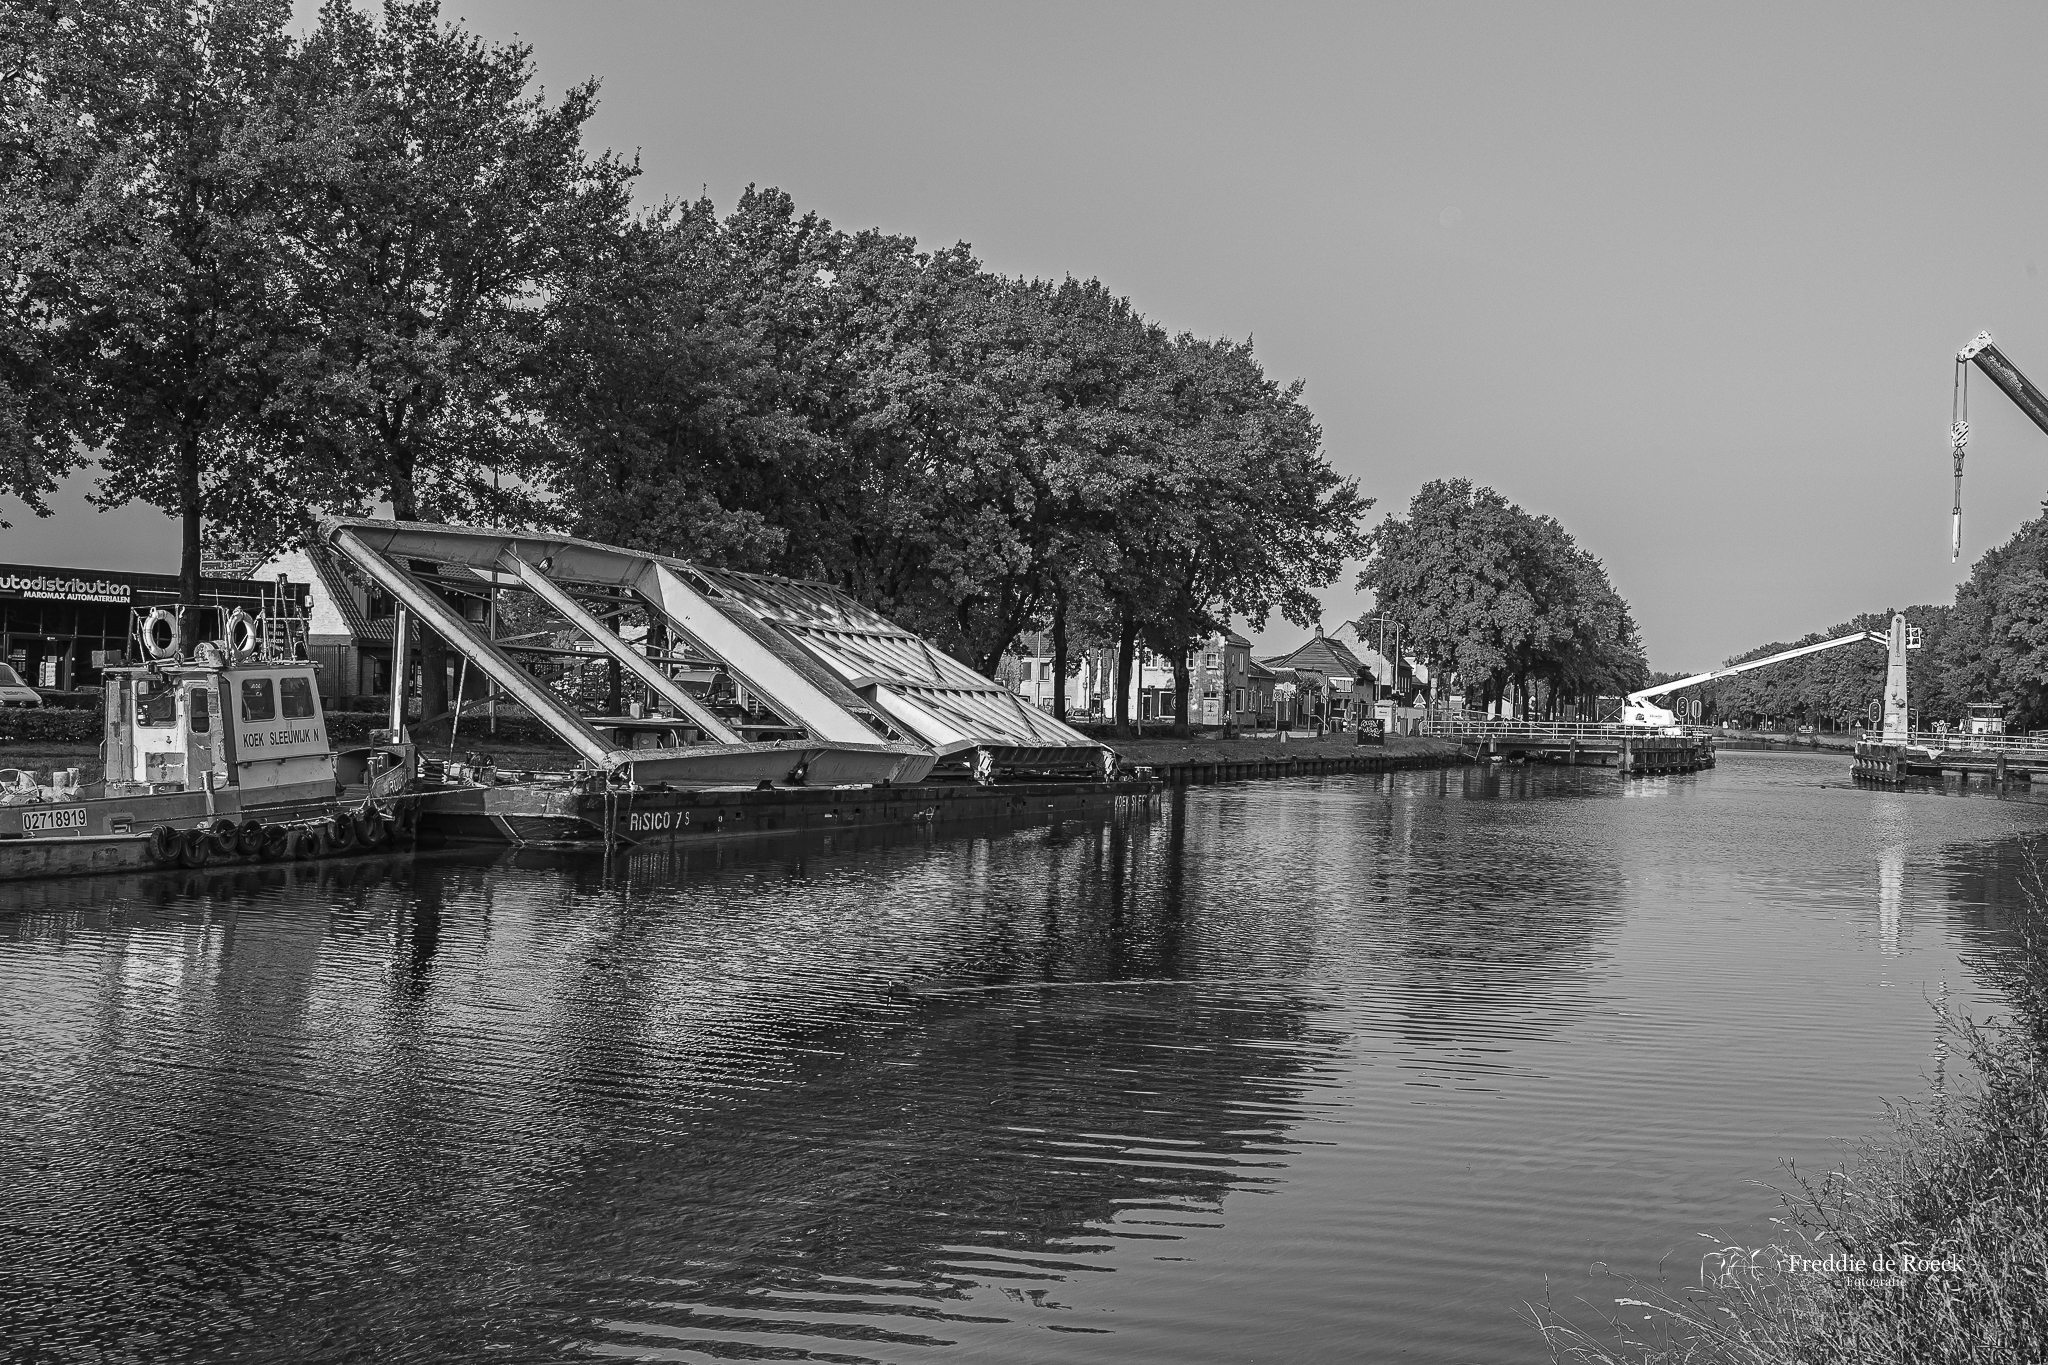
left=0, top=0, right=1370, bottom=722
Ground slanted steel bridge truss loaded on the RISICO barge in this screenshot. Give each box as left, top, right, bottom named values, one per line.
left=322, top=518, right=1116, bottom=784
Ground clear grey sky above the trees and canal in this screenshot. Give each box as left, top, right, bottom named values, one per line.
left=16, top=0, right=2048, bottom=669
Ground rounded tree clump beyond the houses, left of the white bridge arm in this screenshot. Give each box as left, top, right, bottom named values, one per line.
left=1358, top=479, right=1649, bottom=718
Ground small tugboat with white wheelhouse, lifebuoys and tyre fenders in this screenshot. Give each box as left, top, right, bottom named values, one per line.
left=0, top=608, right=414, bottom=882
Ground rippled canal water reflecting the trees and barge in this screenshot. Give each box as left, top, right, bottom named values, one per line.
left=0, top=753, right=2048, bottom=1365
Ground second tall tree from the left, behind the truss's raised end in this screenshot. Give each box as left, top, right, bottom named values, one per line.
left=276, top=0, right=637, bottom=716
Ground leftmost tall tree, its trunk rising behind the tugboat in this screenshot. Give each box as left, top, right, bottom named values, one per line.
left=6, top=0, right=291, bottom=639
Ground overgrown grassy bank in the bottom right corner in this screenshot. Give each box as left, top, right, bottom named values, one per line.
left=1536, top=845, right=2048, bottom=1365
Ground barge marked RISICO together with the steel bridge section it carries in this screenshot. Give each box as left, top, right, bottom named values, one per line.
left=322, top=518, right=1157, bottom=847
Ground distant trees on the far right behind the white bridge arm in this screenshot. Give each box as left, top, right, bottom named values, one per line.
left=1686, top=516, right=2048, bottom=731
